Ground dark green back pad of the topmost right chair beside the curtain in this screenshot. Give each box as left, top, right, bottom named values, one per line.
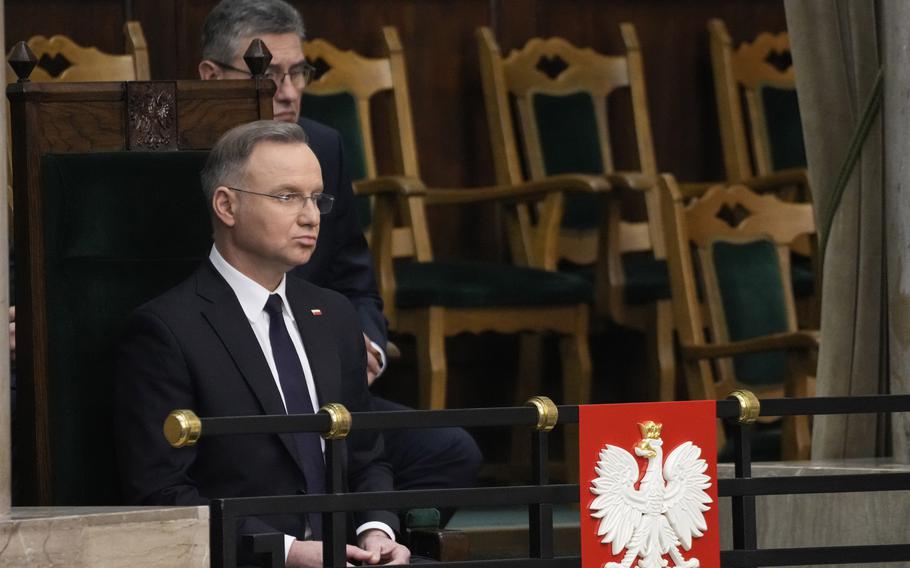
left=759, top=85, right=806, bottom=171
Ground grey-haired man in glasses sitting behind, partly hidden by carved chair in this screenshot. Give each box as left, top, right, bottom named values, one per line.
left=199, top=0, right=482, bottom=500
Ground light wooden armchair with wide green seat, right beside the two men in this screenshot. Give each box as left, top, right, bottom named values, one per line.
left=301, top=27, right=607, bottom=474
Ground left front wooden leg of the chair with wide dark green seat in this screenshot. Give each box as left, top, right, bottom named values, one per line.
left=416, top=307, right=447, bottom=410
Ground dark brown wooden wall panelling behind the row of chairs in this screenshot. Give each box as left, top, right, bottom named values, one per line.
left=6, top=0, right=786, bottom=257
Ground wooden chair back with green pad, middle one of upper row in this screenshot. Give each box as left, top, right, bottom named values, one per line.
left=478, top=23, right=662, bottom=265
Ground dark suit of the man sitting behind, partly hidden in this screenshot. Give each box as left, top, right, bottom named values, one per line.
left=293, top=118, right=483, bottom=489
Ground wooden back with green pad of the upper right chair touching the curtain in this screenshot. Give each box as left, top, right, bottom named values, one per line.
left=708, top=19, right=806, bottom=182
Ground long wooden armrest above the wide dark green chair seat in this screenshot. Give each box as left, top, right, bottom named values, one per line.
left=426, top=174, right=610, bottom=209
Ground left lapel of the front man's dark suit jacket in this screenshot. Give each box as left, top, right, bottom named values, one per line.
left=196, top=261, right=303, bottom=471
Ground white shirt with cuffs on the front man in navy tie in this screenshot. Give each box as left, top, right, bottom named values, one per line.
left=209, top=245, right=395, bottom=559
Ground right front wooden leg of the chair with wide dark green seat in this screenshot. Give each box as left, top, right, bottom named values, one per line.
left=560, top=306, right=591, bottom=483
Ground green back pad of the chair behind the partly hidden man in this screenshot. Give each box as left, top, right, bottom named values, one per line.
left=300, top=93, right=372, bottom=229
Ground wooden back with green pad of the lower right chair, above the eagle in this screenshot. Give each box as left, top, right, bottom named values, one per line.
left=662, top=180, right=815, bottom=398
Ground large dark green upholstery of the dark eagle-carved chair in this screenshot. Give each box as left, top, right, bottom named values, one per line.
left=41, top=152, right=211, bottom=505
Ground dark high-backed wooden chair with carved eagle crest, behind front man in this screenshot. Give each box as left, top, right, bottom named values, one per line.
left=7, top=52, right=274, bottom=505
